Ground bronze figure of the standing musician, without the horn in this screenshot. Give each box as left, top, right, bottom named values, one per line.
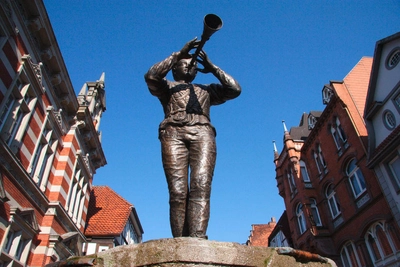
left=145, top=15, right=241, bottom=239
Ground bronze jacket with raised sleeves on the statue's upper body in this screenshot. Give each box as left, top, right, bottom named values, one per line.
left=145, top=53, right=241, bottom=135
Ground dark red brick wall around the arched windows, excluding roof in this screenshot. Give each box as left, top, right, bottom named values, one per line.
left=275, top=94, right=399, bottom=261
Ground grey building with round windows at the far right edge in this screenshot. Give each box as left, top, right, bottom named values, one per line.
left=364, top=33, right=400, bottom=232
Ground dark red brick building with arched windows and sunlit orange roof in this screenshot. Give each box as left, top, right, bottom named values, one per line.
left=274, top=57, right=400, bottom=266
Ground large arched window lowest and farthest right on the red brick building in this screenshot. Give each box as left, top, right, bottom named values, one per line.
left=365, top=222, right=396, bottom=262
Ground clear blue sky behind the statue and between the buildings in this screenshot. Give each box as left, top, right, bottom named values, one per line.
left=44, top=0, right=400, bottom=243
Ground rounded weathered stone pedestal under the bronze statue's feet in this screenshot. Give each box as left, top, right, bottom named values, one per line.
left=48, top=237, right=336, bottom=267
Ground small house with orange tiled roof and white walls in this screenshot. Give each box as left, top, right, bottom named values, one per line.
left=83, top=186, right=143, bottom=255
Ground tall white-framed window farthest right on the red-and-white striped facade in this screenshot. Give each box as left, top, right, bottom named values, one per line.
left=66, top=163, right=88, bottom=225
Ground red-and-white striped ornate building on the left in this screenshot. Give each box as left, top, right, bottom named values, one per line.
left=0, top=0, right=106, bottom=266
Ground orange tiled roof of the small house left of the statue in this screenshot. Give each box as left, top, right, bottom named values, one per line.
left=85, top=186, right=133, bottom=236
